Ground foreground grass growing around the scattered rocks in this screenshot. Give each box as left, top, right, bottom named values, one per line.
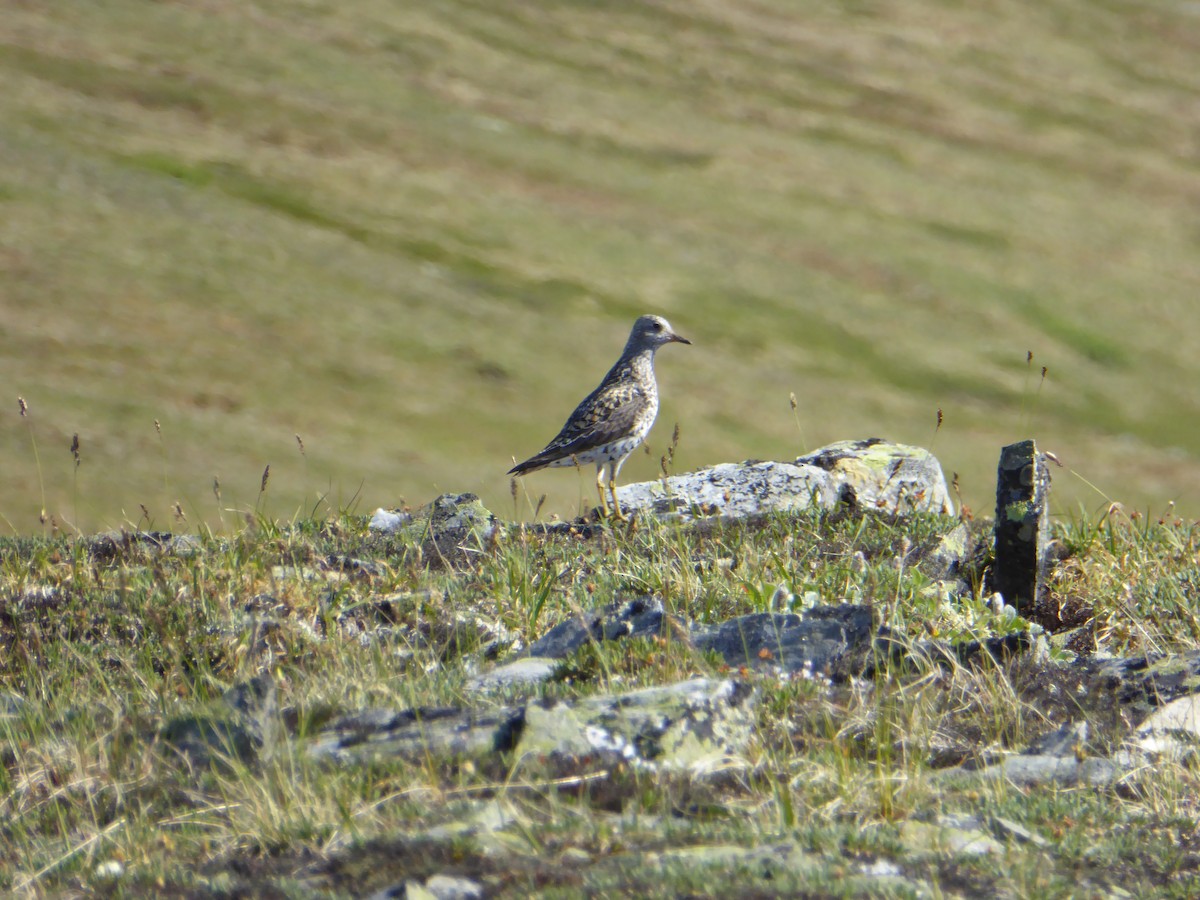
left=0, top=510, right=1200, bottom=896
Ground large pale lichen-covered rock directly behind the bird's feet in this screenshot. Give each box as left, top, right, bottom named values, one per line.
left=617, top=438, right=954, bottom=520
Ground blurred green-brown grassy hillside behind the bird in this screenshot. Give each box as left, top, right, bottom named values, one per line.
left=0, top=0, right=1200, bottom=533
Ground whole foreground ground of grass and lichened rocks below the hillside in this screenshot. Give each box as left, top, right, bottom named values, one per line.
left=0, top=442, right=1200, bottom=898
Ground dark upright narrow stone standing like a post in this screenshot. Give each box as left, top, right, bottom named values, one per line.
left=991, top=440, right=1050, bottom=616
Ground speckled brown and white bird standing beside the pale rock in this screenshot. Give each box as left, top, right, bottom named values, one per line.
left=508, top=316, right=691, bottom=521
